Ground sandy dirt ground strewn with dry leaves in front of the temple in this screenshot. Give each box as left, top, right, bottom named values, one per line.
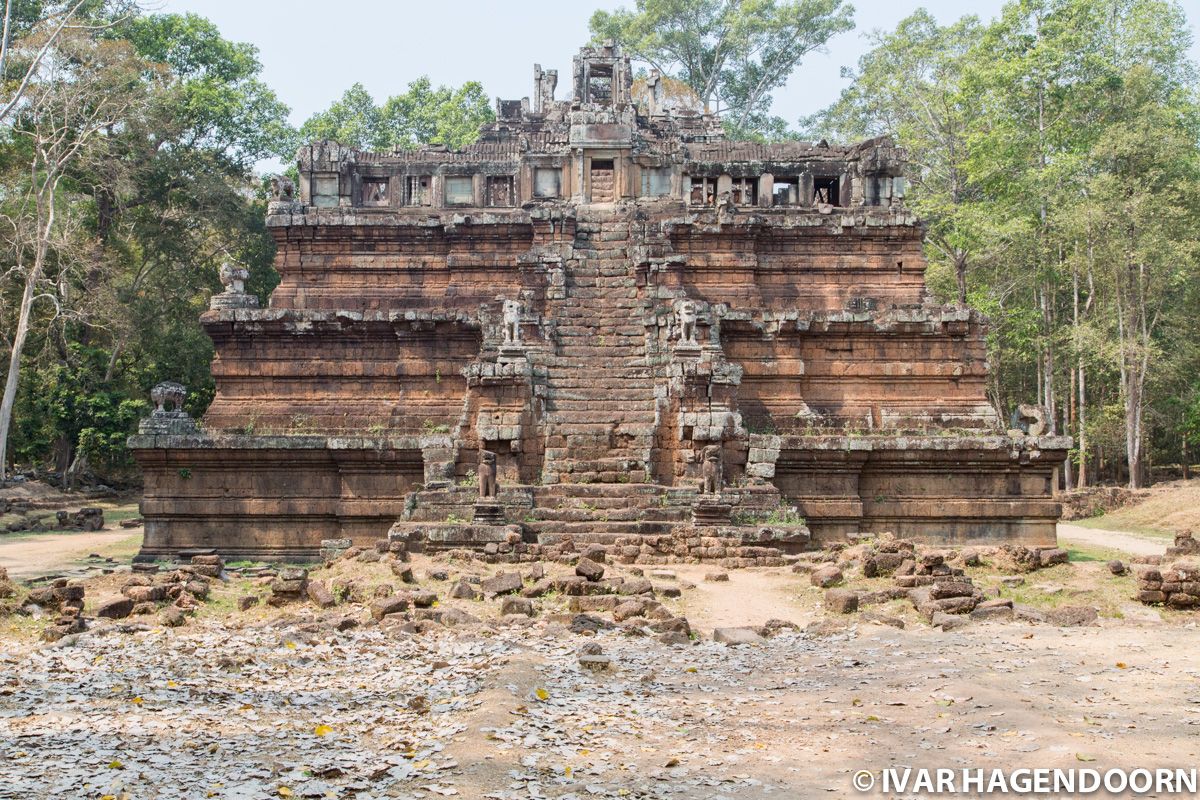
left=0, top=484, right=1200, bottom=800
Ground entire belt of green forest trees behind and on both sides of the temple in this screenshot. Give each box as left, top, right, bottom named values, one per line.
left=0, top=0, right=1200, bottom=494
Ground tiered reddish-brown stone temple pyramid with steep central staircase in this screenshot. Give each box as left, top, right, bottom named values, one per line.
left=130, top=47, right=1070, bottom=564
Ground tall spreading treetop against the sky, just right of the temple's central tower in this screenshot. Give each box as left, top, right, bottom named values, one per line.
left=588, top=0, right=854, bottom=133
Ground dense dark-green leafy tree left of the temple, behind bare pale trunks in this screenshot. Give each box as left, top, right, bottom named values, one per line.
left=0, top=13, right=296, bottom=475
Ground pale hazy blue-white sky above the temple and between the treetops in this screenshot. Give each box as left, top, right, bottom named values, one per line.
left=151, top=0, right=1200, bottom=137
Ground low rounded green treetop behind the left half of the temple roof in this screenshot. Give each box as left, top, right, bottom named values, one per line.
left=300, top=76, right=496, bottom=152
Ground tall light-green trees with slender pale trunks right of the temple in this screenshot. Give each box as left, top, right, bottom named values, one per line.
left=805, top=0, right=1200, bottom=486
